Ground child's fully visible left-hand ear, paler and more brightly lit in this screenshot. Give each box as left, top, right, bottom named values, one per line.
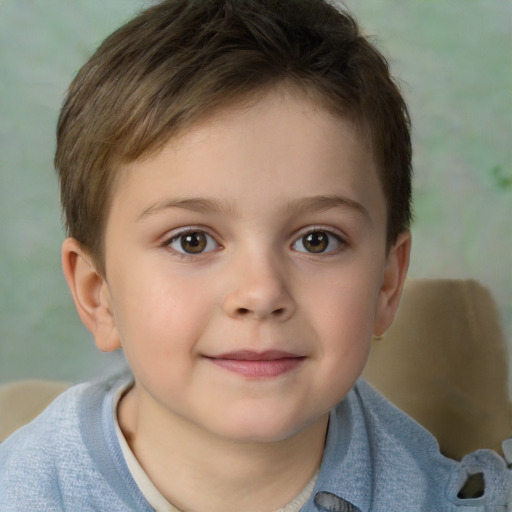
left=61, top=238, right=121, bottom=352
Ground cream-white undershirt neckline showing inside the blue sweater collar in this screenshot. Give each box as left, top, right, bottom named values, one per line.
left=112, top=384, right=318, bottom=512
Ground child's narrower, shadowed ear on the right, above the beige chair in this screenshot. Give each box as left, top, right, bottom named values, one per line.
left=373, top=230, right=411, bottom=336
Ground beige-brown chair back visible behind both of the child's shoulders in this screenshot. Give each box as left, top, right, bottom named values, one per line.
left=0, top=279, right=512, bottom=459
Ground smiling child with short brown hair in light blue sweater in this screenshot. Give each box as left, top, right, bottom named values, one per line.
left=0, top=0, right=512, bottom=512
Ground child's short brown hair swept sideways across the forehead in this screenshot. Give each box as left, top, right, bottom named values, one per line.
left=55, top=0, right=411, bottom=271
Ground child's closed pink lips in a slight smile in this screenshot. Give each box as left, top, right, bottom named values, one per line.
left=207, top=350, right=305, bottom=379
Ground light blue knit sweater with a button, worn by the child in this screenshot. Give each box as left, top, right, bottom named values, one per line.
left=0, top=377, right=512, bottom=512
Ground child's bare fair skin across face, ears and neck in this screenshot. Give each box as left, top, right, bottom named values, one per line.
left=62, top=89, right=410, bottom=512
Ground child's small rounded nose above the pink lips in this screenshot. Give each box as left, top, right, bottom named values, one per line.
left=224, top=252, right=296, bottom=321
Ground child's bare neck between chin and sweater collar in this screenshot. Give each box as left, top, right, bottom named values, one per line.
left=118, top=389, right=328, bottom=512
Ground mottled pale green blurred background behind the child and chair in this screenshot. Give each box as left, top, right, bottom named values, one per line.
left=0, top=0, right=512, bottom=382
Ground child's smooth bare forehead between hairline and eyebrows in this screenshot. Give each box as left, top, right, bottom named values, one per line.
left=110, top=89, right=380, bottom=224
